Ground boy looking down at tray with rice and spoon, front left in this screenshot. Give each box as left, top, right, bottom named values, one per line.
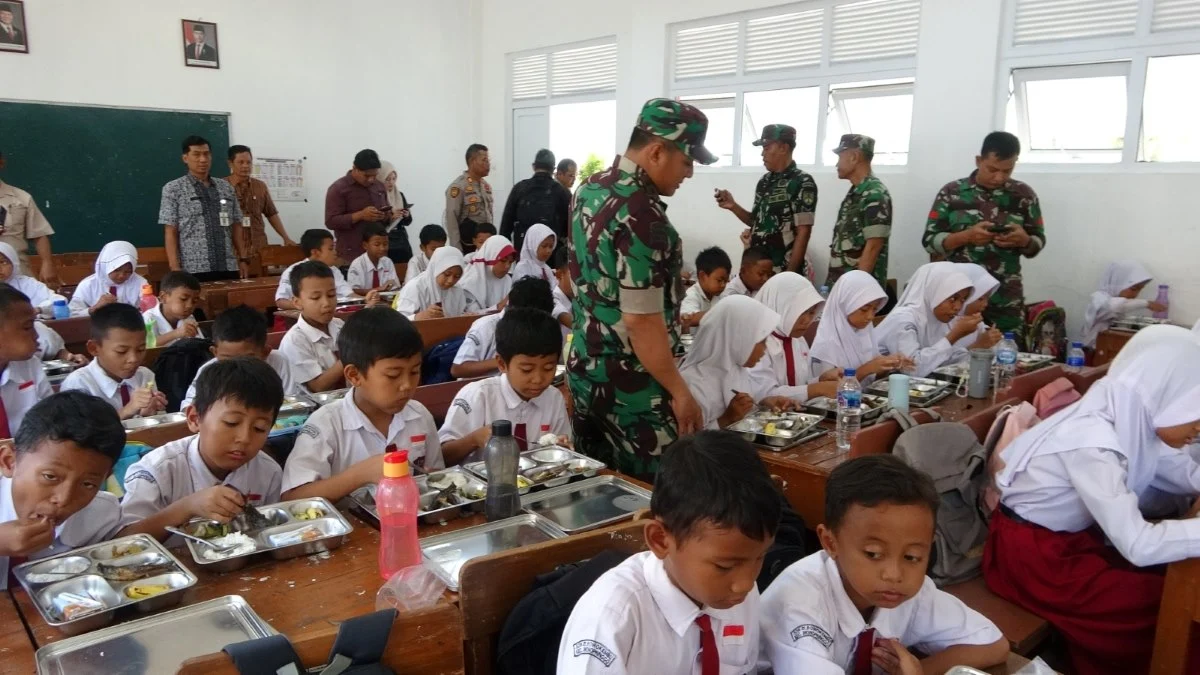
left=121, top=357, right=283, bottom=540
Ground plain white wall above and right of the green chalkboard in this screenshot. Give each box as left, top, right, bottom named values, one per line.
left=9, top=0, right=478, bottom=248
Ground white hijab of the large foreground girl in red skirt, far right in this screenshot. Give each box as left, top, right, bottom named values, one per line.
left=997, top=325, right=1200, bottom=495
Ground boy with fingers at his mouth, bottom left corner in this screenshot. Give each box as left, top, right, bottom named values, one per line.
left=0, top=392, right=125, bottom=590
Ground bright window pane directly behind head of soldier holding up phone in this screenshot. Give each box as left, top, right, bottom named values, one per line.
left=734, top=86, right=821, bottom=167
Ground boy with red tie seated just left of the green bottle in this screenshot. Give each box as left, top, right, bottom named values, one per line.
left=60, top=303, right=167, bottom=419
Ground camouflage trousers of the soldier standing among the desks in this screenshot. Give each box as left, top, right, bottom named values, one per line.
left=566, top=358, right=679, bottom=483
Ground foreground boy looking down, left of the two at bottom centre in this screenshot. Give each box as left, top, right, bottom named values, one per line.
left=557, top=431, right=784, bottom=675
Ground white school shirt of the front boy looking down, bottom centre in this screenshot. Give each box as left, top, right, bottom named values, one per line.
left=556, top=551, right=758, bottom=675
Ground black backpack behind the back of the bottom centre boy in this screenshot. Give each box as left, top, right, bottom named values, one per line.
left=496, top=549, right=631, bottom=675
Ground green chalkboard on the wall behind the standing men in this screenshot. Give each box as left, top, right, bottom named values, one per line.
left=0, top=101, right=229, bottom=253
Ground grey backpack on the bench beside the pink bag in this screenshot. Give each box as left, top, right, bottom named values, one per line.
left=892, top=413, right=989, bottom=586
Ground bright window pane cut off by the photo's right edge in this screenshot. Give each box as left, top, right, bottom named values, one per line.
left=1141, top=54, right=1200, bottom=162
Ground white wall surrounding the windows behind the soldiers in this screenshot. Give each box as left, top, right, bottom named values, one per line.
left=475, top=0, right=1200, bottom=333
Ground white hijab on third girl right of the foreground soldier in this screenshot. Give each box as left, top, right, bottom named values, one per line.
left=811, top=269, right=888, bottom=368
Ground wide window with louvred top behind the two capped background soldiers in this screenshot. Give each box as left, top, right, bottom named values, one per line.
left=667, top=0, right=920, bottom=167
